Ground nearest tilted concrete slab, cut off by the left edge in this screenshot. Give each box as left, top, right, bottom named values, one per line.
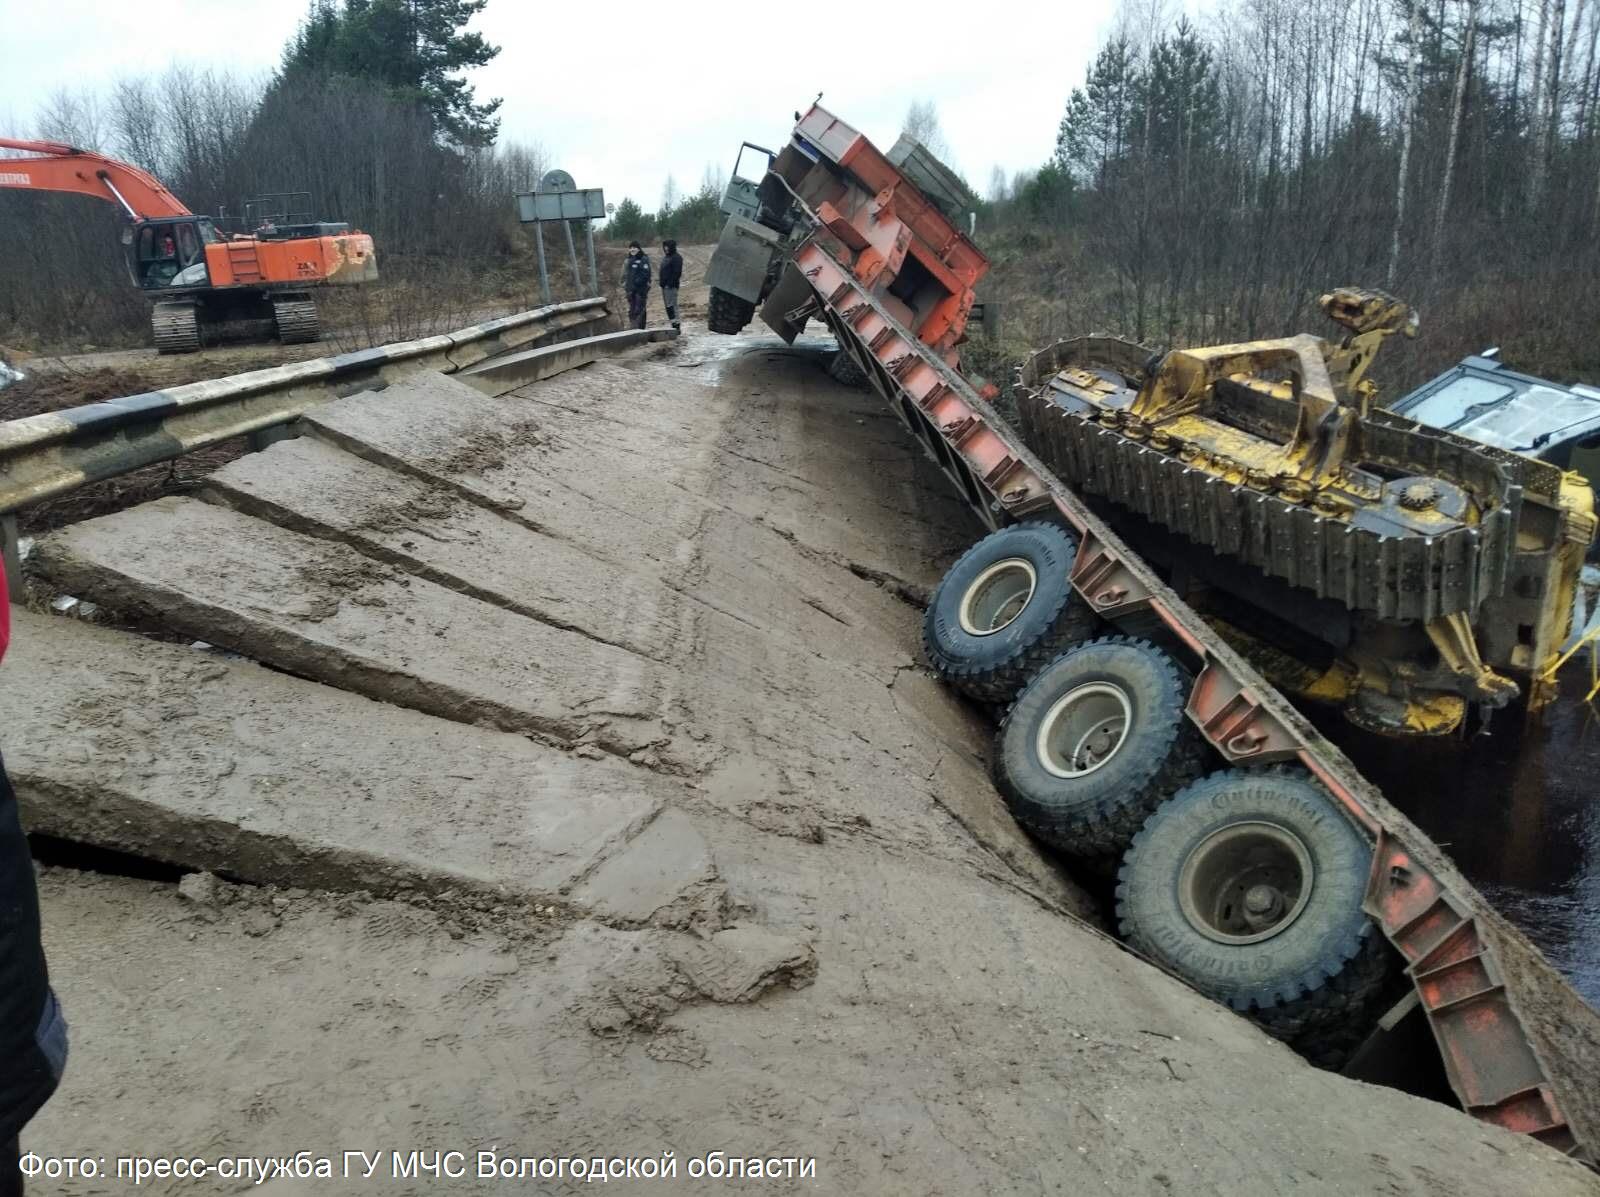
left=0, top=608, right=715, bottom=922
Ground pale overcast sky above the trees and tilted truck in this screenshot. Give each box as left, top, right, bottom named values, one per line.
left=0, top=0, right=1114, bottom=210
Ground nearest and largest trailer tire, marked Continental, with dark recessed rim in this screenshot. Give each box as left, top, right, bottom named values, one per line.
left=1117, top=768, right=1394, bottom=1063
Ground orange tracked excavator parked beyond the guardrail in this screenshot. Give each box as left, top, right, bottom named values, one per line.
left=0, top=138, right=378, bottom=354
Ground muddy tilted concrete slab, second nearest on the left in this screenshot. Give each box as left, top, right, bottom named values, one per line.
left=34, top=498, right=688, bottom=755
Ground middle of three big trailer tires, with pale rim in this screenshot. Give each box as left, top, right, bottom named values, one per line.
left=994, top=637, right=1206, bottom=856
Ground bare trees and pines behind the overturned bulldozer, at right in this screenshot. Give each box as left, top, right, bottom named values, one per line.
left=979, top=0, right=1600, bottom=388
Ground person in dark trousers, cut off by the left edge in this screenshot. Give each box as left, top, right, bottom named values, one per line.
left=0, top=565, right=67, bottom=1197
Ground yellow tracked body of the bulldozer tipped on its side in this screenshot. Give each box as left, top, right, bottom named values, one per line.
left=1019, top=288, right=1595, bottom=735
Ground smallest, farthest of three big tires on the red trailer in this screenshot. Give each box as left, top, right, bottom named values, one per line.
left=922, top=522, right=1099, bottom=706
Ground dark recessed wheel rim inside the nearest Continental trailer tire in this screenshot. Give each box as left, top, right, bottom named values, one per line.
left=1178, top=823, right=1317, bottom=944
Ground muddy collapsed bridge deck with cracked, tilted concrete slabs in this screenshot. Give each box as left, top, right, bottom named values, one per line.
left=9, top=325, right=1600, bottom=1195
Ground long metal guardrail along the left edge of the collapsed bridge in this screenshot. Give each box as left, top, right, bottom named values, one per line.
left=0, top=298, right=606, bottom=576
